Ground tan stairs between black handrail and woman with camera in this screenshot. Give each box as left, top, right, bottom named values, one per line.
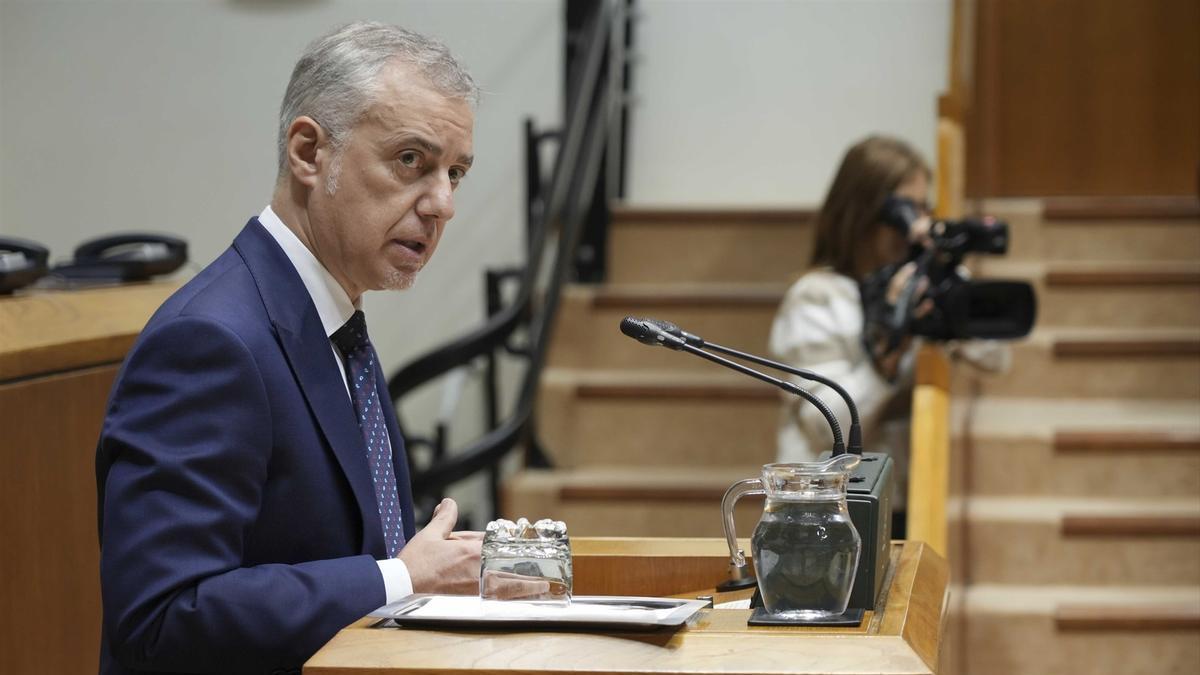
left=505, top=208, right=811, bottom=537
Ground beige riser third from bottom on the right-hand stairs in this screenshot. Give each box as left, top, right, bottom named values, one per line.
left=955, top=432, right=1200, bottom=498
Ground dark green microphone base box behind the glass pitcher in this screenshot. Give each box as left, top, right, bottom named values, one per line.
left=820, top=453, right=895, bottom=609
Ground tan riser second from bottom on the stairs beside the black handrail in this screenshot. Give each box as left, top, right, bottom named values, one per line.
left=538, top=383, right=779, bottom=467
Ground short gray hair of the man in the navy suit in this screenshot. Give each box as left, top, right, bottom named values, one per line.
left=278, top=22, right=479, bottom=178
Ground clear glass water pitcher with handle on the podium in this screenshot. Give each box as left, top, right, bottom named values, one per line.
left=721, top=454, right=863, bottom=621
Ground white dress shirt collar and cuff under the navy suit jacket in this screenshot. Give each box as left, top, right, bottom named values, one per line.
left=258, top=205, right=413, bottom=603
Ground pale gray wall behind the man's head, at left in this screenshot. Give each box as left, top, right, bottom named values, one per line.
left=0, top=0, right=563, bottom=368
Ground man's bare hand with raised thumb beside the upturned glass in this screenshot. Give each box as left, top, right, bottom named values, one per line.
left=396, top=498, right=482, bottom=595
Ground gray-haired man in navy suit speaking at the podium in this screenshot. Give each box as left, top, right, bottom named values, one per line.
left=96, top=23, right=480, bottom=674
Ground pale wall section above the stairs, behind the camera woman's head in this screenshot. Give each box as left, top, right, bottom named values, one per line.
left=629, top=0, right=950, bottom=205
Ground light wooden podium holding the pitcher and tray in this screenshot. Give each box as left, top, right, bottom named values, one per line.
left=304, top=538, right=949, bottom=675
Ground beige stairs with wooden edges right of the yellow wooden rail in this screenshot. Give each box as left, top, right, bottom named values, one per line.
left=949, top=201, right=1200, bottom=675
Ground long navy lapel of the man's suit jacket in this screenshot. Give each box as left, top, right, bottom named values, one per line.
left=234, top=219, right=386, bottom=557
